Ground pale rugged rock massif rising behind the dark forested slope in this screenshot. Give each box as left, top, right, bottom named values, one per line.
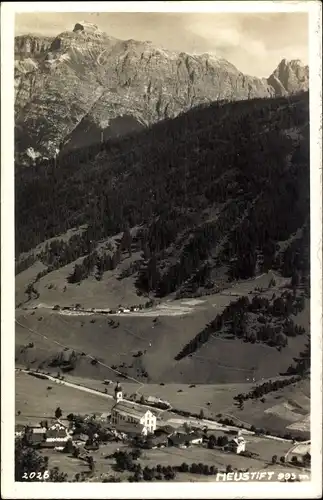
left=15, top=22, right=308, bottom=164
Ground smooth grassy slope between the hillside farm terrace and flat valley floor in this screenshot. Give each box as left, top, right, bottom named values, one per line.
left=16, top=295, right=306, bottom=384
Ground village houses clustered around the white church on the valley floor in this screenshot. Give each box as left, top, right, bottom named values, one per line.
left=15, top=380, right=246, bottom=460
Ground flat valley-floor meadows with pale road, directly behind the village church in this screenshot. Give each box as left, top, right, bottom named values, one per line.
left=16, top=368, right=310, bottom=442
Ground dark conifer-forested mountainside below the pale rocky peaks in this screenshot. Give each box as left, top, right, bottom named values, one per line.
left=16, top=93, right=309, bottom=297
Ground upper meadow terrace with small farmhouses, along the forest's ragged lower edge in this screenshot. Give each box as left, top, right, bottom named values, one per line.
left=16, top=262, right=280, bottom=316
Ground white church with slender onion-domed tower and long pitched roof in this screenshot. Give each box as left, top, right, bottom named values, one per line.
left=111, top=384, right=157, bottom=436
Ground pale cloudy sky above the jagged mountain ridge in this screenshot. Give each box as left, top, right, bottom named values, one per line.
left=15, top=12, right=308, bottom=77
